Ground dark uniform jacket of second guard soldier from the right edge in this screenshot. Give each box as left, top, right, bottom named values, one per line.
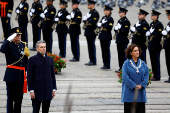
left=148, top=20, right=163, bottom=51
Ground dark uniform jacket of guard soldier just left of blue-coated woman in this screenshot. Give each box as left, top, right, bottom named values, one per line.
left=116, top=17, right=130, bottom=44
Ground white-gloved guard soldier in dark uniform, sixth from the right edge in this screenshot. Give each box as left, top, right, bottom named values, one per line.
left=83, top=0, right=99, bottom=66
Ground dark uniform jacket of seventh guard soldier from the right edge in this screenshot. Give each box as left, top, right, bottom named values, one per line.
left=68, top=8, right=82, bottom=35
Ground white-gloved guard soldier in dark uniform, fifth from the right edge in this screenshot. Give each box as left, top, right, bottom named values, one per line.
left=97, top=5, right=114, bottom=69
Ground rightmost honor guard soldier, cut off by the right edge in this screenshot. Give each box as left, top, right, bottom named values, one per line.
left=162, top=10, right=170, bottom=83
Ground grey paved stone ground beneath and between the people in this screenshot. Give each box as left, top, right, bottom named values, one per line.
left=0, top=0, right=170, bottom=113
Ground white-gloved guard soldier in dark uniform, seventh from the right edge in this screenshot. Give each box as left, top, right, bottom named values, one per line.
left=66, top=0, right=82, bottom=62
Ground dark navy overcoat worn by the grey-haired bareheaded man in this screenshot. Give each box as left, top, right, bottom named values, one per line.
left=27, top=53, right=57, bottom=100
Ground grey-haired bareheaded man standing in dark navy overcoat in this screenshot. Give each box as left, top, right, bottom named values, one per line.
left=27, top=41, right=57, bottom=113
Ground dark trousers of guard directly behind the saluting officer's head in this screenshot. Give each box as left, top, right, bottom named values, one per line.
left=19, top=23, right=28, bottom=45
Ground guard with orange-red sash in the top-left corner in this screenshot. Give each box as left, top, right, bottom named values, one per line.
left=0, top=0, right=14, bottom=40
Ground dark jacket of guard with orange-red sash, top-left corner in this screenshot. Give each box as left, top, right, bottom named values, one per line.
left=0, top=0, right=14, bottom=17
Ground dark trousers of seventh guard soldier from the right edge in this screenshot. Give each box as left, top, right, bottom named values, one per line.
left=70, top=35, right=80, bottom=61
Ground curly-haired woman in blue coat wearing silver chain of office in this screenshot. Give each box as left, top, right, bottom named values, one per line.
left=121, top=44, right=149, bottom=113
